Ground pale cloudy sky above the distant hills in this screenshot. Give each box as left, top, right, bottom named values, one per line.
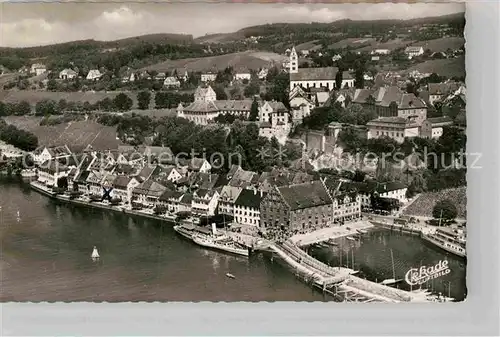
left=0, top=0, right=465, bottom=47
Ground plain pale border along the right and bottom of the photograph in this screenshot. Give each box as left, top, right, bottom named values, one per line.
left=0, top=1, right=500, bottom=336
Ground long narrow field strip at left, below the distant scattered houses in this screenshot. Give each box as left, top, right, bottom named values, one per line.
left=0, top=90, right=141, bottom=107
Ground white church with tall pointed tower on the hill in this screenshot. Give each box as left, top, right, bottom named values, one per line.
left=289, top=47, right=354, bottom=91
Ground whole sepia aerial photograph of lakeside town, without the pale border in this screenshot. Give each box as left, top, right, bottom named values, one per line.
left=0, top=2, right=471, bottom=303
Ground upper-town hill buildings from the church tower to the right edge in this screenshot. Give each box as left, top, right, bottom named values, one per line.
left=289, top=47, right=466, bottom=142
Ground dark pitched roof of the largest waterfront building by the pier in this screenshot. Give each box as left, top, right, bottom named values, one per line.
left=278, top=180, right=332, bottom=210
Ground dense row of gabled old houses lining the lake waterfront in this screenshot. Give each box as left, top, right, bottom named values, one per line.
left=33, top=146, right=407, bottom=231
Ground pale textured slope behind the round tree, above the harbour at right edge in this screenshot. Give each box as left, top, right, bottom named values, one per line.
left=403, top=186, right=467, bottom=219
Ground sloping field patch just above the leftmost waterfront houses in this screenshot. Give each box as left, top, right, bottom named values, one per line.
left=4, top=116, right=122, bottom=150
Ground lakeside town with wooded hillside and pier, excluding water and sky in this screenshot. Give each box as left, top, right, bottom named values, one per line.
left=0, top=3, right=466, bottom=302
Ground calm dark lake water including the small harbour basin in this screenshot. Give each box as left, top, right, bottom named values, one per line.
left=0, top=178, right=465, bottom=302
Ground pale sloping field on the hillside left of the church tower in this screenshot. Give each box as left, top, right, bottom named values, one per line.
left=141, top=51, right=287, bottom=71
